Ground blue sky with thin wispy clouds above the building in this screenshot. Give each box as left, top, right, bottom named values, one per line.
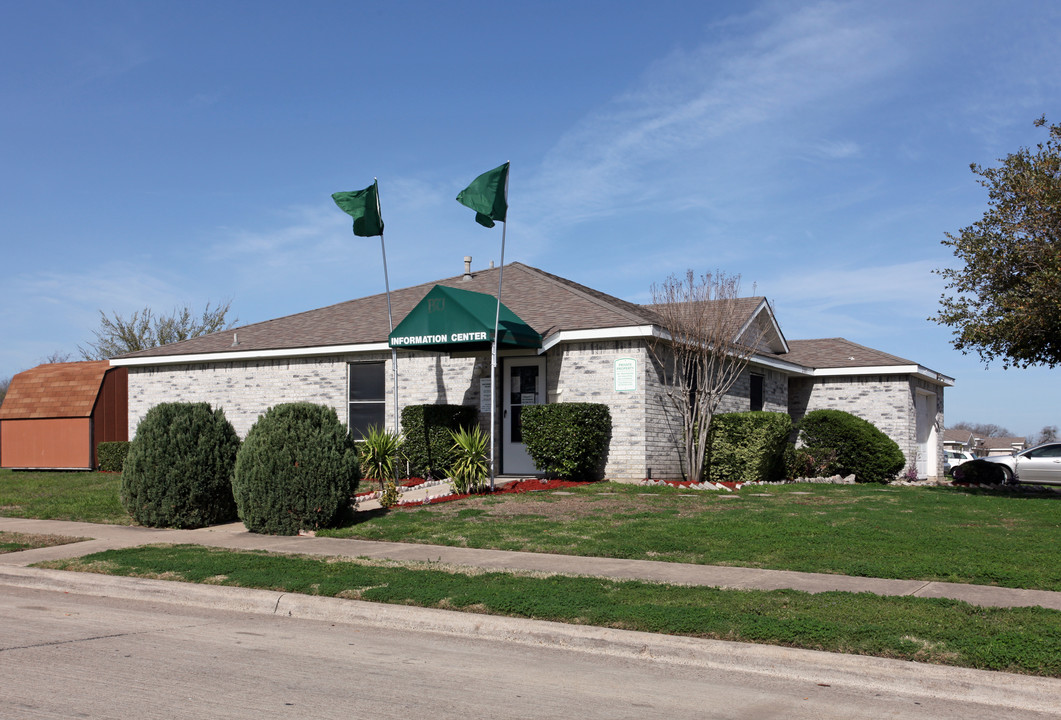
left=0, top=0, right=1061, bottom=434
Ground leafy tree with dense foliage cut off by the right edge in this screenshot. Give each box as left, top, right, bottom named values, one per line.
left=930, top=118, right=1061, bottom=368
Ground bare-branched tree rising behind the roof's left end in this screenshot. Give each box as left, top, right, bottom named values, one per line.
left=77, top=300, right=239, bottom=359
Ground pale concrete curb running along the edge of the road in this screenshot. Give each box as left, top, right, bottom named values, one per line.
left=0, top=566, right=1061, bottom=713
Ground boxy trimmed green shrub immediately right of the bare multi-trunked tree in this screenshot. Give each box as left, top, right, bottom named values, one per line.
left=706, top=411, right=793, bottom=482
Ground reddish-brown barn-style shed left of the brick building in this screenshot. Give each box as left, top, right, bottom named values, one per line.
left=0, top=361, right=128, bottom=470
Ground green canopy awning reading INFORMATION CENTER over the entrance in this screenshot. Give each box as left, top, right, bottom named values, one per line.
left=388, top=285, right=541, bottom=350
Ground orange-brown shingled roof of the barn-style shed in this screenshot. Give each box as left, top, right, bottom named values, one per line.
left=0, top=361, right=110, bottom=420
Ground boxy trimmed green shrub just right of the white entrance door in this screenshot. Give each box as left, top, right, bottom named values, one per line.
left=520, top=403, right=611, bottom=480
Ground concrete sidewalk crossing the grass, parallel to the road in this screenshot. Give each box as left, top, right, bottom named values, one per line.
left=0, top=517, right=1061, bottom=610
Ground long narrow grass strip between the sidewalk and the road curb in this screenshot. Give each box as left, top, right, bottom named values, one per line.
left=38, top=545, right=1061, bottom=677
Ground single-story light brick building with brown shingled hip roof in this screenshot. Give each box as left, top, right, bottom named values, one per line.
left=111, top=263, right=953, bottom=480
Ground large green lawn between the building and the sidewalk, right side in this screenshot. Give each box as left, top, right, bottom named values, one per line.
left=318, top=484, right=1061, bottom=591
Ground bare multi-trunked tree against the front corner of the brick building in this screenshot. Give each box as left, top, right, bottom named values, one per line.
left=648, top=270, right=766, bottom=482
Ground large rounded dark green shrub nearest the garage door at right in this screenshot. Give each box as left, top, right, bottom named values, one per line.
left=799, top=410, right=906, bottom=482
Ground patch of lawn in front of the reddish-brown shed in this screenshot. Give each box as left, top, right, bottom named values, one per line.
left=0, top=470, right=133, bottom=525
